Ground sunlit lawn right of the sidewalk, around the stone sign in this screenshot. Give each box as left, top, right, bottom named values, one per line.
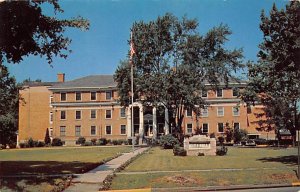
left=112, top=147, right=297, bottom=189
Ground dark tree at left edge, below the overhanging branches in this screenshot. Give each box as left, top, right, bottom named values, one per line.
left=0, top=65, right=19, bottom=145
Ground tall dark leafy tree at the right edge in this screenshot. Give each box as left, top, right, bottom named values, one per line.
left=243, top=1, right=300, bottom=138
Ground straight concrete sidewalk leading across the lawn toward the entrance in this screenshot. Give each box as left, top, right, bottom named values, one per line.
left=64, top=147, right=148, bottom=192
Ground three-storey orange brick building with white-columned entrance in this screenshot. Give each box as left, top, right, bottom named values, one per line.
left=19, top=74, right=275, bottom=145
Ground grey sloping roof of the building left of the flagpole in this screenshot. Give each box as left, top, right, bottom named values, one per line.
left=50, top=75, right=117, bottom=90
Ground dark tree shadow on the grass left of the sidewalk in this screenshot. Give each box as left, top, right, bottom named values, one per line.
left=0, top=161, right=100, bottom=191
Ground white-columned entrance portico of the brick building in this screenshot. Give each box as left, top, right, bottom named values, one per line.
left=127, top=103, right=169, bottom=144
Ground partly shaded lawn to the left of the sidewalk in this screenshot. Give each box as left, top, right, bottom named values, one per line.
left=0, top=146, right=131, bottom=191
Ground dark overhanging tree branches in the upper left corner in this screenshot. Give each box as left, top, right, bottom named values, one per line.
left=0, top=0, right=89, bottom=64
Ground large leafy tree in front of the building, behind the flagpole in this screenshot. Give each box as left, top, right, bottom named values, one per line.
left=115, top=14, right=243, bottom=140
